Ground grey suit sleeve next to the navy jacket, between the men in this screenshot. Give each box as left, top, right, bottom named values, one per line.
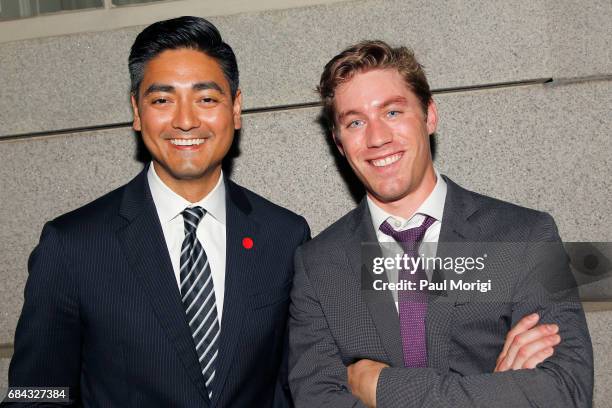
left=289, top=248, right=365, bottom=408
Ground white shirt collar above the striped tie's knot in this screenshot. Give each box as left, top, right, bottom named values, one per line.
left=147, top=162, right=225, bottom=225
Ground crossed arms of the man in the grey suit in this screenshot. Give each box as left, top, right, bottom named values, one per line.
left=289, top=217, right=593, bottom=408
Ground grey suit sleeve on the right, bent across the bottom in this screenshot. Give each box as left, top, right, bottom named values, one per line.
left=376, top=214, right=593, bottom=408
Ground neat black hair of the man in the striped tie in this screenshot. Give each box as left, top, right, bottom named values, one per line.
left=128, top=16, right=238, bottom=100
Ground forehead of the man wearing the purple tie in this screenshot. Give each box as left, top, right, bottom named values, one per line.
left=334, top=69, right=417, bottom=113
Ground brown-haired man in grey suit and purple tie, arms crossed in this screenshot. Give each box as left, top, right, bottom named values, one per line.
left=289, top=41, right=593, bottom=408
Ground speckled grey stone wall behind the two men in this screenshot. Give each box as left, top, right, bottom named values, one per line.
left=0, top=0, right=612, bottom=407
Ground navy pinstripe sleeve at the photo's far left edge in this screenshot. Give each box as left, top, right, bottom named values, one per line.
left=3, top=224, right=81, bottom=406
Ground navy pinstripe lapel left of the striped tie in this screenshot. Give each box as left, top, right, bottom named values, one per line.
left=117, top=167, right=209, bottom=405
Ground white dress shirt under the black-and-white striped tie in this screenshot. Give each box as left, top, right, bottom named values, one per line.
left=147, top=163, right=227, bottom=324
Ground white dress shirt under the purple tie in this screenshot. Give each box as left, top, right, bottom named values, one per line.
left=367, top=170, right=447, bottom=310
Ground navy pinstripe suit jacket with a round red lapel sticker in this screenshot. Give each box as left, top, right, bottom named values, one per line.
left=9, top=168, right=310, bottom=407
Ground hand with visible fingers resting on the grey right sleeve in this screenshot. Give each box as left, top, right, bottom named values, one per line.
left=494, top=313, right=561, bottom=373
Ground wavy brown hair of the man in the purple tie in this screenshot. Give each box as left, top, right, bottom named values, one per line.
left=317, top=40, right=432, bottom=129
